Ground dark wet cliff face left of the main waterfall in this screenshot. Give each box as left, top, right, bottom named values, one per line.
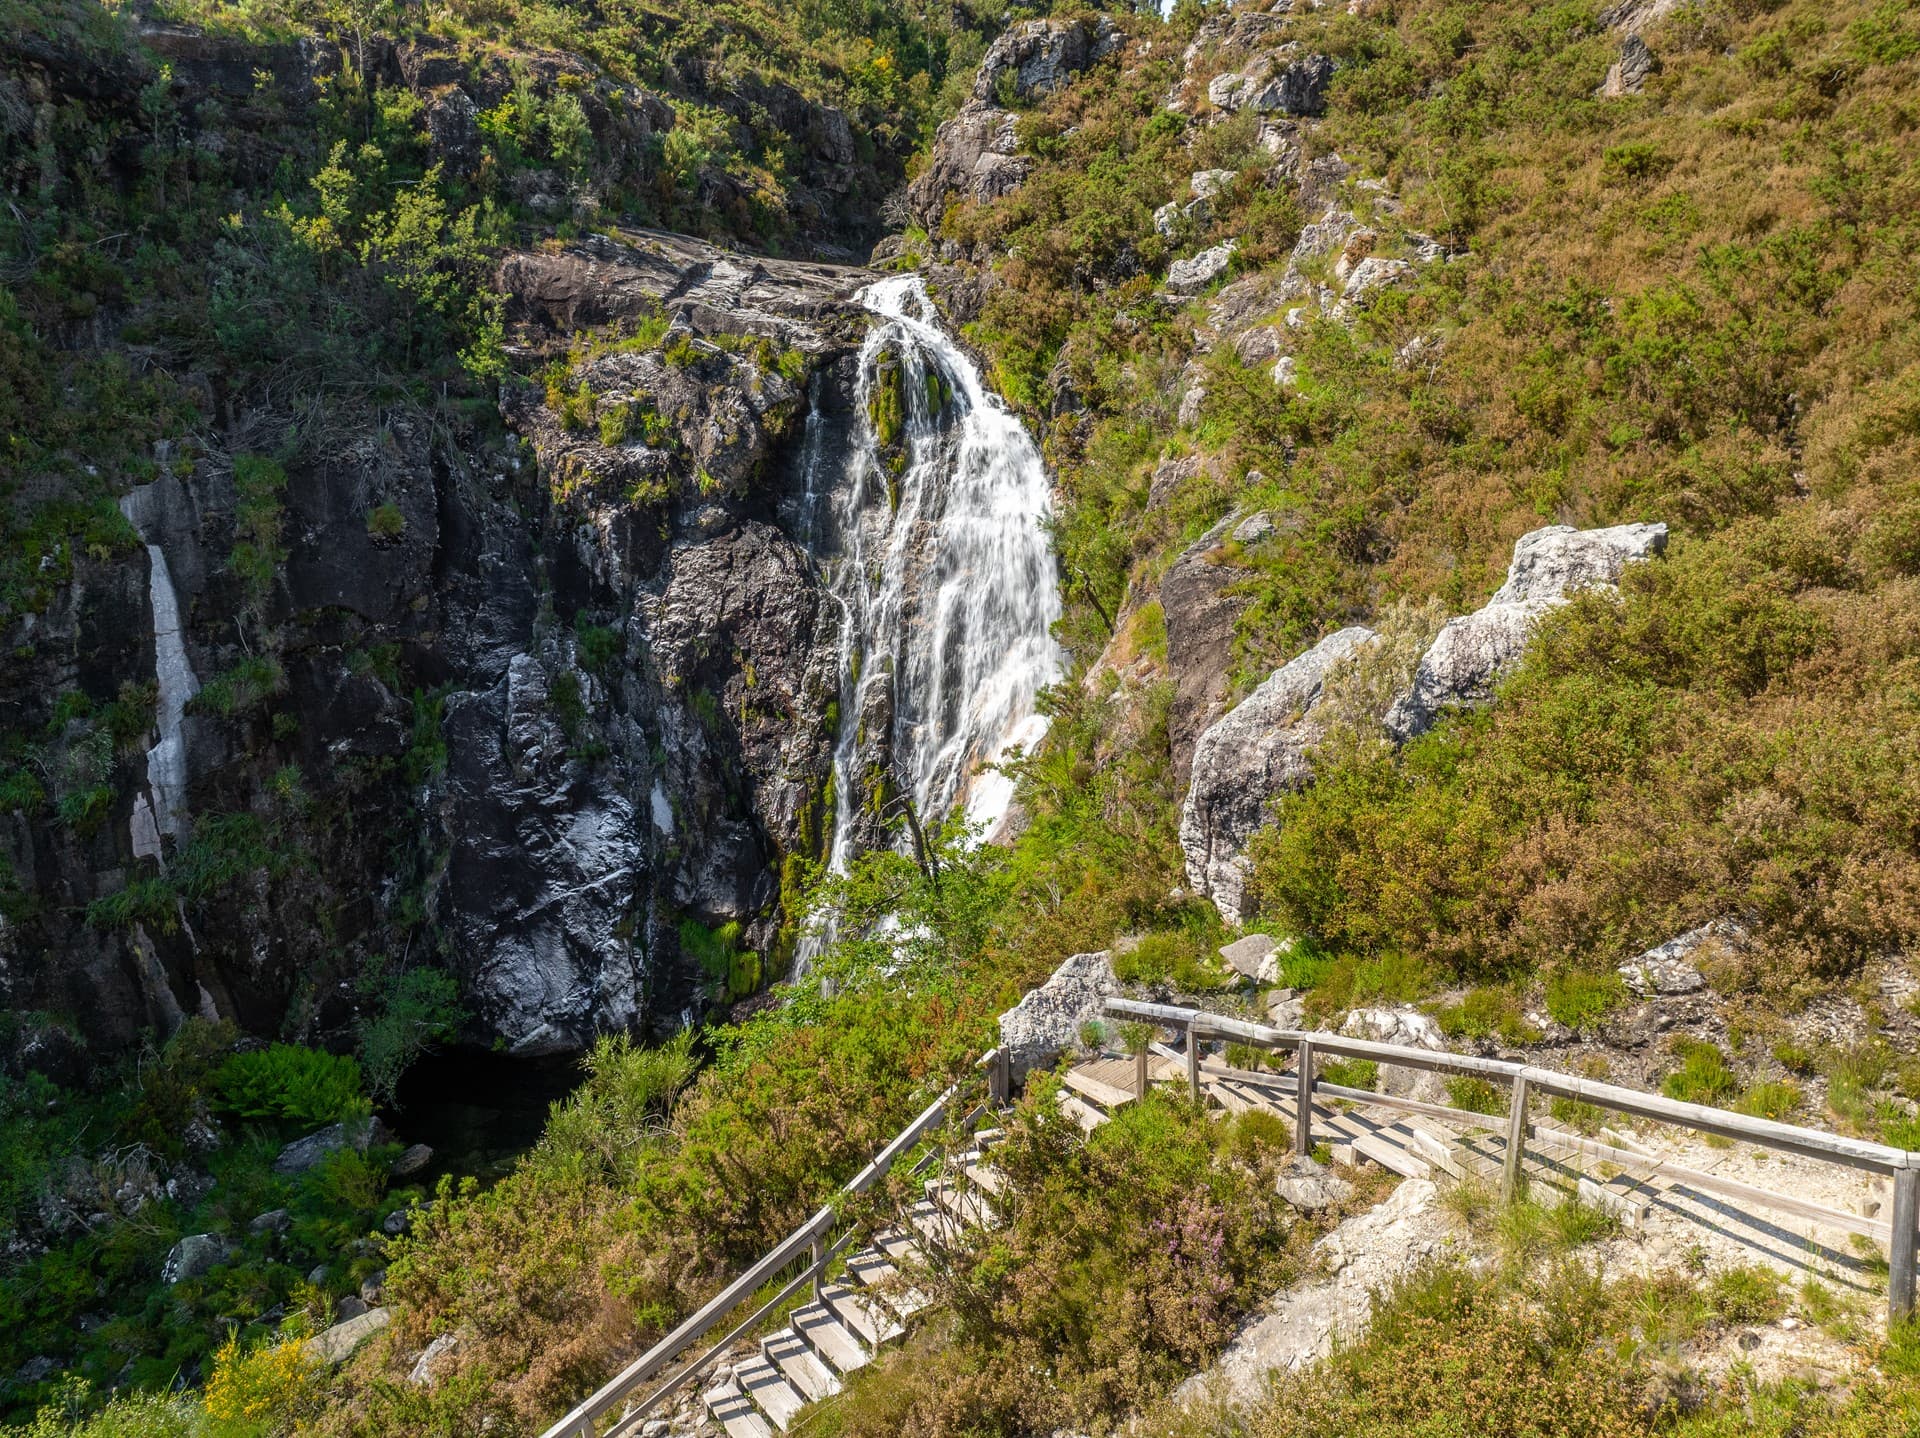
left=0, top=224, right=872, bottom=1067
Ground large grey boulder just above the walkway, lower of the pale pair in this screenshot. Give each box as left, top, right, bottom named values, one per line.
left=1181, top=624, right=1373, bottom=923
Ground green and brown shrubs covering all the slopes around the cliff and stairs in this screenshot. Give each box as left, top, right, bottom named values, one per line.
left=11, top=0, right=1920, bottom=1438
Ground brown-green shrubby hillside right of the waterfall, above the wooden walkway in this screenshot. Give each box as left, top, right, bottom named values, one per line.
left=945, top=2, right=1920, bottom=1029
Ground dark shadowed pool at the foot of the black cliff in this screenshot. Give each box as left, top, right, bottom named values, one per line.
left=384, top=1048, right=582, bottom=1179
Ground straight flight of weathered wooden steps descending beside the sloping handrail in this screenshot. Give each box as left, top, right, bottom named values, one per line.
left=701, top=1129, right=1004, bottom=1438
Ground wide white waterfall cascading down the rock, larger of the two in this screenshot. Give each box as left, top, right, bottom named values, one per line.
left=801, top=276, right=1060, bottom=910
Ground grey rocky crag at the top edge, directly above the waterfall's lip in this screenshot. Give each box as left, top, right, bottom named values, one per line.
left=906, top=15, right=1121, bottom=234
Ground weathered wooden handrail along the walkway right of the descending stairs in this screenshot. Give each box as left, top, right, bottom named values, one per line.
left=1104, top=998, right=1920, bottom=1319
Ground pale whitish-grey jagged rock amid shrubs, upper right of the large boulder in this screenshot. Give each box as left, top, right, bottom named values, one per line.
left=1386, top=524, right=1667, bottom=741
